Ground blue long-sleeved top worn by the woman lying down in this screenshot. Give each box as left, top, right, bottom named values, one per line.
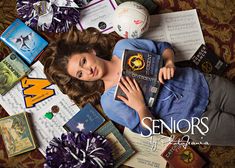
left=101, top=39, right=209, bottom=134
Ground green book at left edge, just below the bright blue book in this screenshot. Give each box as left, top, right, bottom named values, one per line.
left=0, top=53, right=30, bottom=95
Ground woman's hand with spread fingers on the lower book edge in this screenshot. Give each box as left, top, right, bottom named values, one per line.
left=118, top=77, right=146, bottom=112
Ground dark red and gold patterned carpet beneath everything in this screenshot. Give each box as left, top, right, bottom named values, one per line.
left=0, top=0, right=235, bottom=168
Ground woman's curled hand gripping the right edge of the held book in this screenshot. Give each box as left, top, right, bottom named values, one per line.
left=158, top=60, right=175, bottom=84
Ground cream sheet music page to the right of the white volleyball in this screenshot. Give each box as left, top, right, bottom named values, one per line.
left=143, top=9, right=205, bottom=62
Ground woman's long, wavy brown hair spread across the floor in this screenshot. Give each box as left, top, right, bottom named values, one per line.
left=43, top=28, right=119, bottom=107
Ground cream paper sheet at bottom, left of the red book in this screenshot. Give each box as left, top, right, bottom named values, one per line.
left=123, top=128, right=170, bottom=168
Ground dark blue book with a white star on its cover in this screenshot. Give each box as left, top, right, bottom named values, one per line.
left=63, top=104, right=105, bottom=133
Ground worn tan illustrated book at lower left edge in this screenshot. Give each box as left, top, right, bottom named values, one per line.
left=0, top=112, right=36, bottom=157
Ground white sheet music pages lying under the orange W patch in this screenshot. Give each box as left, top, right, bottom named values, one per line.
left=0, top=61, right=80, bottom=156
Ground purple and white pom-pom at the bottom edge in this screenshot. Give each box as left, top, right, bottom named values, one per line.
left=44, top=132, right=113, bottom=168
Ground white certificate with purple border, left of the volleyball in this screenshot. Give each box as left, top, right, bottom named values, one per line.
left=76, top=0, right=117, bottom=33
